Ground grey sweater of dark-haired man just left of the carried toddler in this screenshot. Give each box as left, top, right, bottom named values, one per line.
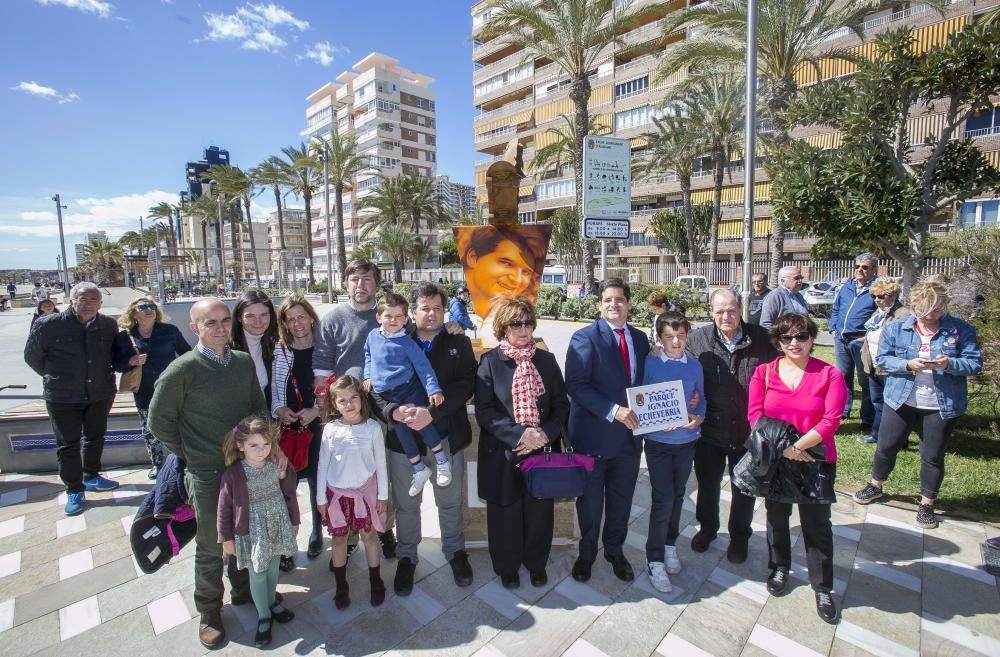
left=313, top=303, right=378, bottom=378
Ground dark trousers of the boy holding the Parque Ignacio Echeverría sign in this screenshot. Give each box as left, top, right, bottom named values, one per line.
left=643, top=440, right=698, bottom=561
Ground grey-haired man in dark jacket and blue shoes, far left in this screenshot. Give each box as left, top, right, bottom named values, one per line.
left=24, top=283, right=118, bottom=516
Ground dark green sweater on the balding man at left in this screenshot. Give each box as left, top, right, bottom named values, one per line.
left=149, top=349, right=270, bottom=472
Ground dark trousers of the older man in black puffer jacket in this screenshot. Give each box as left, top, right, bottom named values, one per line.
left=694, top=440, right=754, bottom=541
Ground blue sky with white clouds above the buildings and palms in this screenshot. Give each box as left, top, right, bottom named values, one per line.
left=0, top=0, right=475, bottom=269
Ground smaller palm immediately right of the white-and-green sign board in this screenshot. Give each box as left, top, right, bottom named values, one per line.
left=639, top=113, right=704, bottom=268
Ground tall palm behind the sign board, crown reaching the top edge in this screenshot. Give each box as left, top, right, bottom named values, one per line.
left=473, top=0, right=648, bottom=289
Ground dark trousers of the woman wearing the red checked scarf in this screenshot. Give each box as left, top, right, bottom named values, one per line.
left=486, top=482, right=555, bottom=576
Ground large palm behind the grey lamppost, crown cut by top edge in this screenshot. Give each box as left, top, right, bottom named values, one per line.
left=658, top=0, right=900, bottom=280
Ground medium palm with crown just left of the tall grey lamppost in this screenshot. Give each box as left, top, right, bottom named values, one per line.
left=665, top=68, right=745, bottom=276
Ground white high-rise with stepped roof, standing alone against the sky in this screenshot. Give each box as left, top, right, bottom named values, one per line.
left=304, top=52, right=437, bottom=285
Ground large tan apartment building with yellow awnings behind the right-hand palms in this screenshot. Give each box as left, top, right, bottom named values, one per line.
left=471, top=0, right=1000, bottom=276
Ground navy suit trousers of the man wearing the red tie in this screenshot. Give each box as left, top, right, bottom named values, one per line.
left=576, top=438, right=640, bottom=561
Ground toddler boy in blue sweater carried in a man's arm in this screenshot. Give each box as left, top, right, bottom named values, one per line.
left=365, top=292, right=451, bottom=497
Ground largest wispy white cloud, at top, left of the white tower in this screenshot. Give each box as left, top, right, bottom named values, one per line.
left=203, top=2, right=309, bottom=52
